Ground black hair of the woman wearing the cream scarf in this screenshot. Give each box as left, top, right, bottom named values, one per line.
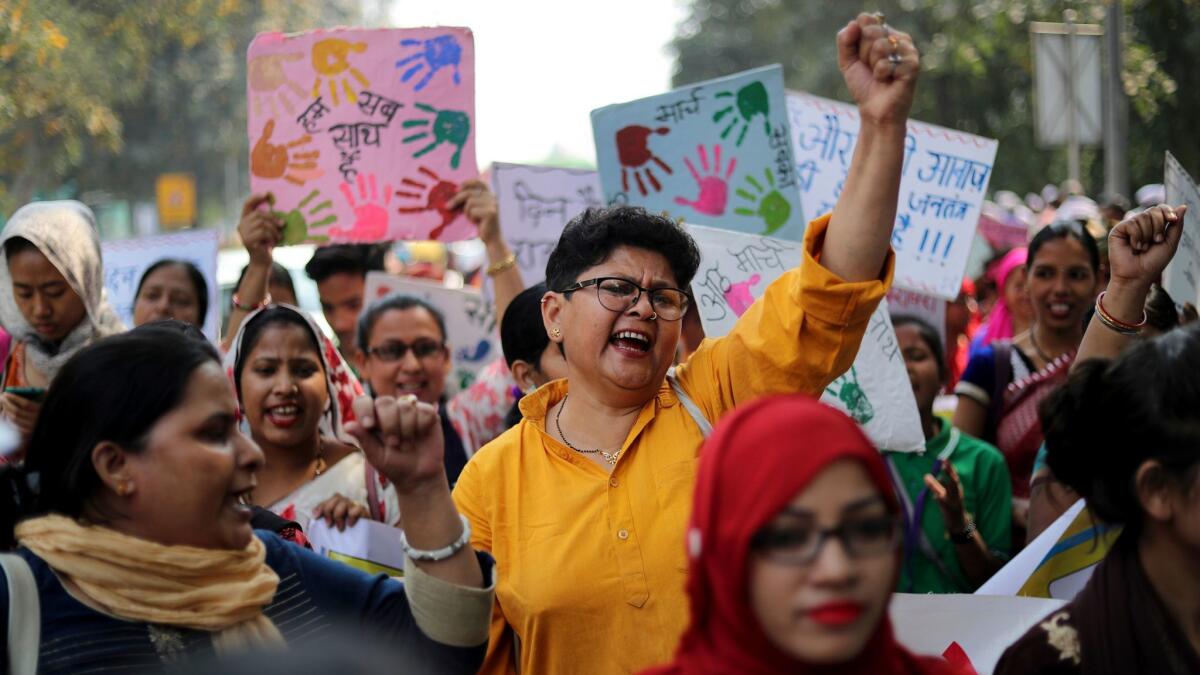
left=0, top=321, right=221, bottom=549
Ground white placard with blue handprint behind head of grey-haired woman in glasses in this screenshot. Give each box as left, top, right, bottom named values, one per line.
left=365, top=271, right=503, bottom=390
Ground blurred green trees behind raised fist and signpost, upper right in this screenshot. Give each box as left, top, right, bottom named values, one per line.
left=673, top=0, right=1200, bottom=195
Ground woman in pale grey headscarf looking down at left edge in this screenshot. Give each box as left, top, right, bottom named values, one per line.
left=0, top=201, right=125, bottom=451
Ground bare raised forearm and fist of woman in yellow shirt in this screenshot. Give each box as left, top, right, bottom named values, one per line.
left=821, top=13, right=920, bottom=281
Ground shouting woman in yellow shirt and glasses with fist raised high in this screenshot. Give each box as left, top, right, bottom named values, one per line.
left=454, top=14, right=918, bottom=675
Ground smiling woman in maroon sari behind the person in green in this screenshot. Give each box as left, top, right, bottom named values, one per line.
left=954, top=222, right=1100, bottom=530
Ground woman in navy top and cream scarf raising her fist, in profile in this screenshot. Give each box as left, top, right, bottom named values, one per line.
left=0, top=324, right=492, bottom=673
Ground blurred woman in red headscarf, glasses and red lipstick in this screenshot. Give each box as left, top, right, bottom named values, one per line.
left=647, top=395, right=956, bottom=675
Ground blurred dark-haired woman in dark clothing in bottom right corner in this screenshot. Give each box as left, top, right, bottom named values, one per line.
left=996, top=296, right=1200, bottom=675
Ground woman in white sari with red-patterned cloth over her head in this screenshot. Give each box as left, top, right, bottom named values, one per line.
left=226, top=305, right=400, bottom=528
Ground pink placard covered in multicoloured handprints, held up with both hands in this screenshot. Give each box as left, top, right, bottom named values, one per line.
left=247, top=28, right=478, bottom=244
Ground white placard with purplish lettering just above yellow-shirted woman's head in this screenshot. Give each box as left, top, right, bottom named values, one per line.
left=492, top=163, right=604, bottom=286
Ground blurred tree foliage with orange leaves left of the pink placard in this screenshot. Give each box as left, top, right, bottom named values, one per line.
left=0, top=0, right=364, bottom=220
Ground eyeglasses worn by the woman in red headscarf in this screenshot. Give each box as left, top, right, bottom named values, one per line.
left=750, top=515, right=900, bottom=565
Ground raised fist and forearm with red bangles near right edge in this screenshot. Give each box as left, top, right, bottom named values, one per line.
left=1073, top=204, right=1188, bottom=365
